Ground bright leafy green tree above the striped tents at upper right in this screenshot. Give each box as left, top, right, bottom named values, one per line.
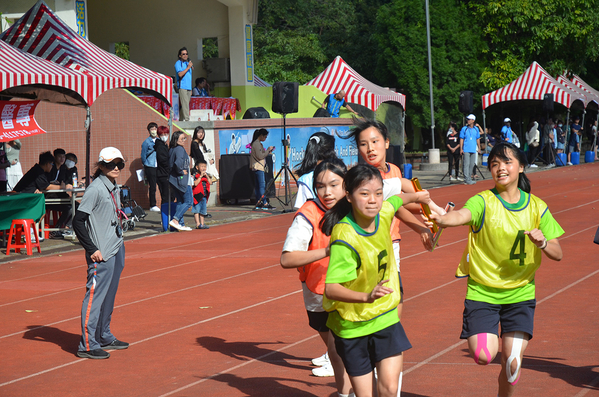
left=469, top=0, right=599, bottom=90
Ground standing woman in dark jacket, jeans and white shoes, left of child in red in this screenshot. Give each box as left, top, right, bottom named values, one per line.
left=168, top=131, right=193, bottom=231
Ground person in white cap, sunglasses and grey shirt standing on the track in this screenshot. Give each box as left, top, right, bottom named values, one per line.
left=73, top=147, right=129, bottom=359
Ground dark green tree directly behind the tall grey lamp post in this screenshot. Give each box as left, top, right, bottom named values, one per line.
left=376, top=0, right=484, bottom=147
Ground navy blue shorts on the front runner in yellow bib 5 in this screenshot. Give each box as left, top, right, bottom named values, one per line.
left=333, top=322, right=412, bottom=376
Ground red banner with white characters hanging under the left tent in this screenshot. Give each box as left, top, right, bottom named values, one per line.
left=0, top=101, right=46, bottom=142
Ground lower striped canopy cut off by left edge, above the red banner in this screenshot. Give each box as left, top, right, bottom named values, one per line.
left=0, top=40, right=87, bottom=106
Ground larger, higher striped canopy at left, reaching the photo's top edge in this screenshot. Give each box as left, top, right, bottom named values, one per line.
left=0, top=0, right=173, bottom=106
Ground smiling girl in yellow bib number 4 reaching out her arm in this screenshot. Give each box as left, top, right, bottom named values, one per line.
left=432, top=142, right=564, bottom=397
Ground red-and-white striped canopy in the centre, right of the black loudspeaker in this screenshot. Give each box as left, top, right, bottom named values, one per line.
left=305, top=56, right=406, bottom=111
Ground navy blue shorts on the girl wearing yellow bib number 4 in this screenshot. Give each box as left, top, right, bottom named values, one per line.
left=460, top=299, right=537, bottom=339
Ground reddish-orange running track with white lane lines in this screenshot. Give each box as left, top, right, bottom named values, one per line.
left=0, top=164, right=599, bottom=397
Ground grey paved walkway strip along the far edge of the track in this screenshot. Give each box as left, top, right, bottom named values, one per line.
left=0, top=159, right=564, bottom=264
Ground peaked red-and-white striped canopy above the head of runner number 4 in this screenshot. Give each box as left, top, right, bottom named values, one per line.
left=482, top=62, right=586, bottom=109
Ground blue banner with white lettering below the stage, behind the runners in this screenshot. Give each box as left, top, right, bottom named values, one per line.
left=219, top=126, right=358, bottom=174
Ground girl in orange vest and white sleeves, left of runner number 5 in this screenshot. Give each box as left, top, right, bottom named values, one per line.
left=281, top=158, right=354, bottom=397
